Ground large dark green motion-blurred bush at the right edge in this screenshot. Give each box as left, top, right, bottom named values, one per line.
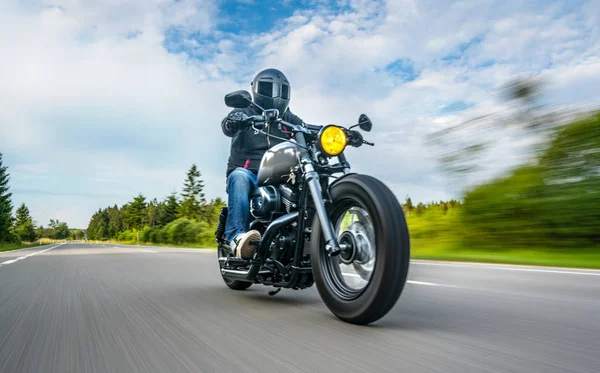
left=463, top=113, right=600, bottom=249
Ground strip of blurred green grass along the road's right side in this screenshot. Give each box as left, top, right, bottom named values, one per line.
left=411, top=240, right=600, bottom=269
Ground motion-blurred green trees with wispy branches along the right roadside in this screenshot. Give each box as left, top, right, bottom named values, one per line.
left=420, top=75, right=600, bottom=251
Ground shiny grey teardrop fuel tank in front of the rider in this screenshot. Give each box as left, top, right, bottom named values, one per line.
left=257, top=141, right=300, bottom=186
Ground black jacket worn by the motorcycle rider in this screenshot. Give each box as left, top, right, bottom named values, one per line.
left=221, top=107, right=303, bottom=176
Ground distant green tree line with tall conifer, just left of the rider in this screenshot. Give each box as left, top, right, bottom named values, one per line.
left=86, top=164, right=225, bottom=246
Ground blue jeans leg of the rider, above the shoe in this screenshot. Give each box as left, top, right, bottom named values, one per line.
left=225, top=168, right=258, bottom=242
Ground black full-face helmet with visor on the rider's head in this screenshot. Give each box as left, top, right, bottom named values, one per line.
left=251, top=69, right=291, bottom=115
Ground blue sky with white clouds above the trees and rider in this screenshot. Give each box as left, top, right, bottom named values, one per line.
left=0, top=0, right=600, bottom=228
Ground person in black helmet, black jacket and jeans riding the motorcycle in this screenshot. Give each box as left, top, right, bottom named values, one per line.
left=221, top=68, right=303, bottom=259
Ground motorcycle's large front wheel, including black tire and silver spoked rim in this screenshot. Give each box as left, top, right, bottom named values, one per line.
left=311, top=175, right=410, bottom=324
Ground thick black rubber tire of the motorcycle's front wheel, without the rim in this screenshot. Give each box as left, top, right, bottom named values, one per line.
left=311, top=174, right=410, bottom=325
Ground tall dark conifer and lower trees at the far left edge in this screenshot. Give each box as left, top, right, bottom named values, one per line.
left=0, top=153, right=72, bottom=245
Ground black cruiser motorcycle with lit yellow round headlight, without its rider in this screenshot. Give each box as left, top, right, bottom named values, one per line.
left=215, top=91, right=410, bottom=325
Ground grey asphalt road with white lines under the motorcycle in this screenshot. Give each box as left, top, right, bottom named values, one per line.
left=0, top=244, right=600, bottom=373
